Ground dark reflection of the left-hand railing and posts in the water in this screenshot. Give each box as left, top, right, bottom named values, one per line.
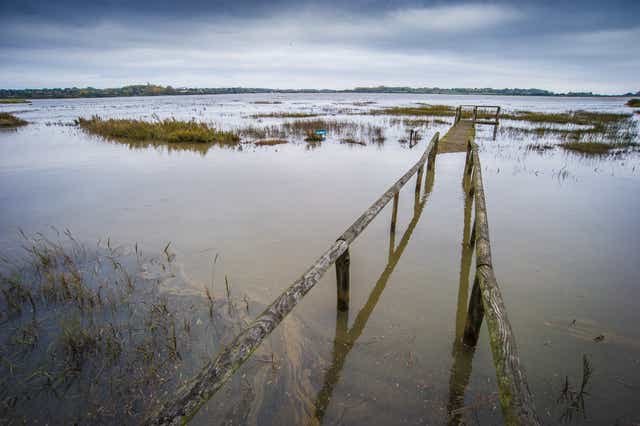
left=315, top=145, right=437, bottom=423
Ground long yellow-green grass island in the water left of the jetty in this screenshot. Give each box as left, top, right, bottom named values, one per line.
left=76, top=116, right=240, bottom=146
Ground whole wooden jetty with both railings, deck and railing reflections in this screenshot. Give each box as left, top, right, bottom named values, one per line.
left=146, top=106, right=540, bottom=425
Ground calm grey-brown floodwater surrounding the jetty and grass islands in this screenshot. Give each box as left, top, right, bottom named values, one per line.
left=0, top=94, right=640, bottom=425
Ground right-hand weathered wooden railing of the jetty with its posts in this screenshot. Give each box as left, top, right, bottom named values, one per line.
left=463, top=140, right=540, bottom=425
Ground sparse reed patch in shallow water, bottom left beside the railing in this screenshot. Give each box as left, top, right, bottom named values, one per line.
left=0, top=230, right=252, bottom=424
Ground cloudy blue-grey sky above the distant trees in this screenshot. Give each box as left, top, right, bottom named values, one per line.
left=0, top=0, right=640, bottom=94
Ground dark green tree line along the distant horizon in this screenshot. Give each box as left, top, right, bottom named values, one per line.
left=0, top=84, right=640, bottom=99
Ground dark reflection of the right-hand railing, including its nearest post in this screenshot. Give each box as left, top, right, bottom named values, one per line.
left=447, top=152, right=484, bottom=425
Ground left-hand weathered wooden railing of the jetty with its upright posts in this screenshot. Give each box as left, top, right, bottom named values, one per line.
left=147, top=133, right=440, bottom=425
